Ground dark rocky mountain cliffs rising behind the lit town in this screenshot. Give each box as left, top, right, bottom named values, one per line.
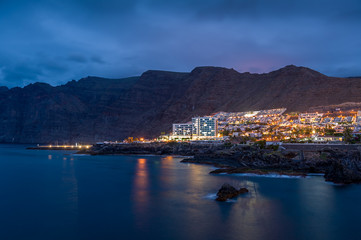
left=0, top=66, right=361, bottom=143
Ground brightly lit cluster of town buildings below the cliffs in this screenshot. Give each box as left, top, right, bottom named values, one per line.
left=163, top=108, right=361, bottom=142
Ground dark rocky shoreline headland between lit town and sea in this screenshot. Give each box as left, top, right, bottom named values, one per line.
left=79, top=142, right=361, bottom=184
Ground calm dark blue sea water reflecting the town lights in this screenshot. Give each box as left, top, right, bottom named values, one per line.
left=0, top=145, right=361, bottom=240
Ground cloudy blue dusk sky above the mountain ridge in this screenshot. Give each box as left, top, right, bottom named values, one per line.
left=0, top=0, right=361, bottom=87
